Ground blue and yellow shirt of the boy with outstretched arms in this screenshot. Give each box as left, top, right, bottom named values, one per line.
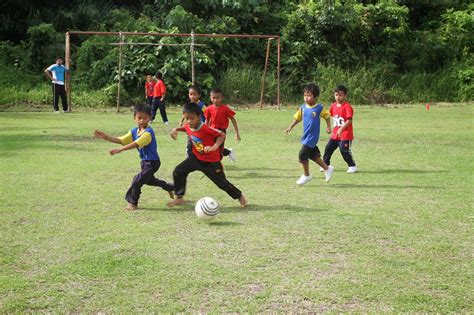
left=119, top=127, right=160, bottom=161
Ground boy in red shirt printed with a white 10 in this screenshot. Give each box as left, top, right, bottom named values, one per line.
left=323, top=85, right=357, bottom=174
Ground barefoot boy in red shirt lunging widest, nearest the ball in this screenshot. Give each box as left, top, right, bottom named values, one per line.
left=168, top=103, right=248, bottom=207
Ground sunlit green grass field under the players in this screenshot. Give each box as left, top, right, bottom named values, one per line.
left=0, top=105, right=474, bottom=313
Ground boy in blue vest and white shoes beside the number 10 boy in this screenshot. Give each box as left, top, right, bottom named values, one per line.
left=286, top=83, right=334, bottom=185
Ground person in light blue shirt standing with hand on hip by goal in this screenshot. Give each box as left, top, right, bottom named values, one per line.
left=44, top=57, right=69, bottom=113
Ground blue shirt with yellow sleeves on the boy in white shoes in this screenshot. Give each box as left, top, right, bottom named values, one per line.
left=293, top=104, right=329, bottom=148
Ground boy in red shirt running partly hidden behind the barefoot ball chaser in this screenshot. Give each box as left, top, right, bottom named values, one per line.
left=204, top=88, right=240, bottom=162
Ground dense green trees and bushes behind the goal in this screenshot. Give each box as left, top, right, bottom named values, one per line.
left=0, top=0, right=474, bottom=105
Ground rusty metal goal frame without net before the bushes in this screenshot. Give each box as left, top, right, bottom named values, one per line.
left=65, top=31, right=281, bottom=111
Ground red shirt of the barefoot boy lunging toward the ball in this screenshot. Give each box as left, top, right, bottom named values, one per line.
left=184, top=124, right=222, bottom=162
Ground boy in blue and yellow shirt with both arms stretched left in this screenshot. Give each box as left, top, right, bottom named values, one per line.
left=94, top=105, right=174, bottom=210
